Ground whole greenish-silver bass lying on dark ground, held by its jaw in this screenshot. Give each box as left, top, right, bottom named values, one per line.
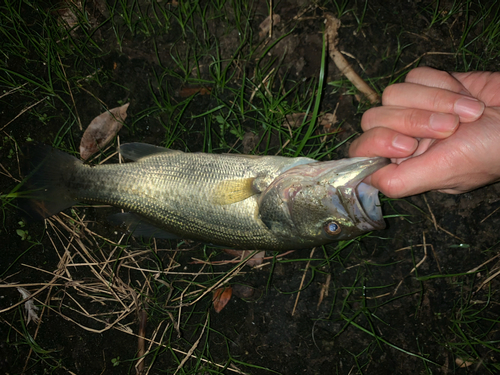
left=20, top=143, right=390, bottom=250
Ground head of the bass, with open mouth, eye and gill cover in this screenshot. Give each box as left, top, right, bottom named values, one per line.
left=259, top=158, right=390, bottom=247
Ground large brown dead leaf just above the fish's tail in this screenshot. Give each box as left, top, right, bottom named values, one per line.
left=80, top=103, right=130, bottom=160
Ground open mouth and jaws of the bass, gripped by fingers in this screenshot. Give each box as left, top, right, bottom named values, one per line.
left=328, top=158, right=390, bottom=231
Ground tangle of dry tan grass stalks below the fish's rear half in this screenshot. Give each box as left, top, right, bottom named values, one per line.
left=0, top=211, right=258, bottom=374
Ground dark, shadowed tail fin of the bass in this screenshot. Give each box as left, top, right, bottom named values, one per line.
left=16, top=145, right=83, bottom=220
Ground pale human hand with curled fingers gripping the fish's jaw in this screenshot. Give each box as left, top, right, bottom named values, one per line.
left=349, top=67, right=500, bottom=198
